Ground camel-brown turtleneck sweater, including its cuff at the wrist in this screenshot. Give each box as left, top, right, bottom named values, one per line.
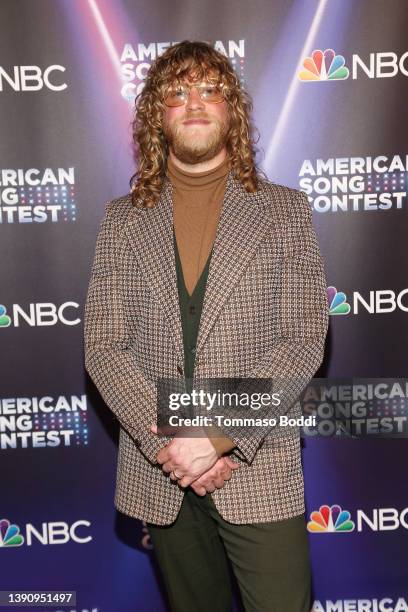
left=167, top=157, right=235, bottom=456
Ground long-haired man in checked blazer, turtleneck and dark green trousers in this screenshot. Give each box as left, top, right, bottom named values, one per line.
left=85, top=41, right=328, bottom=612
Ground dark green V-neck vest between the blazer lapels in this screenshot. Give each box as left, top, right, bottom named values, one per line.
left=173, top=227, right=212, bottom=390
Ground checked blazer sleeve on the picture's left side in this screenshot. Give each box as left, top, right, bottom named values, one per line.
left=84, top=202, right=167, bottom=464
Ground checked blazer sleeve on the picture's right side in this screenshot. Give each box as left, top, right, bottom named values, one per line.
left=226, top=190, right=328, bottom=464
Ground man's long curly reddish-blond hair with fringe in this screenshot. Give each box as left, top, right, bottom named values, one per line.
left=129, top=40, right=260, bottom=208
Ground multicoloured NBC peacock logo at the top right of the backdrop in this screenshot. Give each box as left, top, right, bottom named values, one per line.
left=298, top=49, right=349, bottom=82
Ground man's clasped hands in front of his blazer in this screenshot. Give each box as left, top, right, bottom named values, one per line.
left=151, top=425, right=239, bottom=496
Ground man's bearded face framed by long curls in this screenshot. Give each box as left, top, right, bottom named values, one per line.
left=163, top=75, right=229, bottom=164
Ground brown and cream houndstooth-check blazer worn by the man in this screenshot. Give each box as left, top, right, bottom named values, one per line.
left=84, top=172, right=328, bottom=525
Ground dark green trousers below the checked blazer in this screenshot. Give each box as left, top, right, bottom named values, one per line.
left=147, top=489, right=311, bottom=612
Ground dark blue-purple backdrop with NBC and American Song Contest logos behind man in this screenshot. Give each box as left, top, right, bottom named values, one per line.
left=0, top=0, right=408, bottom=612
